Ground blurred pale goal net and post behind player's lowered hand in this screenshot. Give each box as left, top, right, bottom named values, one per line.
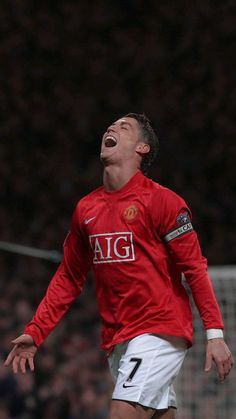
left=175, top=266, right=236, bottom=419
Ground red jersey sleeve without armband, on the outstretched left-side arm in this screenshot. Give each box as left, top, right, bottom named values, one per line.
left=24, top=207, right=91, bottom=346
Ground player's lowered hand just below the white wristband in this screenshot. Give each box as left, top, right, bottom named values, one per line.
left=205, top=338, right=234, bottom=382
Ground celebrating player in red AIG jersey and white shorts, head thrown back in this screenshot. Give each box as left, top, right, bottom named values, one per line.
left=5, top=113, right=233, bottom=419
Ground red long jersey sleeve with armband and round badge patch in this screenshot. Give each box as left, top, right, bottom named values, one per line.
left=152, top=189, right=224, bottom=330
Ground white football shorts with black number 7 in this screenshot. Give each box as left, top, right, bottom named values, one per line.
left=109, top=333, right=187, bottom=410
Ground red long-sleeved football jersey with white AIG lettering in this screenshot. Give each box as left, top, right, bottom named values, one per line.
left=25, top=172, right=223, bottom=350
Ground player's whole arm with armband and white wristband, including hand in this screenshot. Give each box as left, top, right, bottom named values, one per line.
left=153, top=189, right=233, bottom=381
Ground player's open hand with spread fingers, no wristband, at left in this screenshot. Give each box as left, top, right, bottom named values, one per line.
left=4, top=334, right=37, bottom=374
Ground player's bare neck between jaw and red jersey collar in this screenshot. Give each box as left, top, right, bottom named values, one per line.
left=103, top=166, right=138, bottom=192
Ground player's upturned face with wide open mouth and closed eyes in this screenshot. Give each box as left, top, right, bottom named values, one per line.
left=100, top=117, right=141, bottom=163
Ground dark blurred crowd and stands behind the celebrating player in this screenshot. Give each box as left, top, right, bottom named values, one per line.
left=0, top=0, right=236, bottom=419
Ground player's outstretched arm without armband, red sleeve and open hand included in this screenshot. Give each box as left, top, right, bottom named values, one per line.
left=5, top=205, right=91, bottom=373
